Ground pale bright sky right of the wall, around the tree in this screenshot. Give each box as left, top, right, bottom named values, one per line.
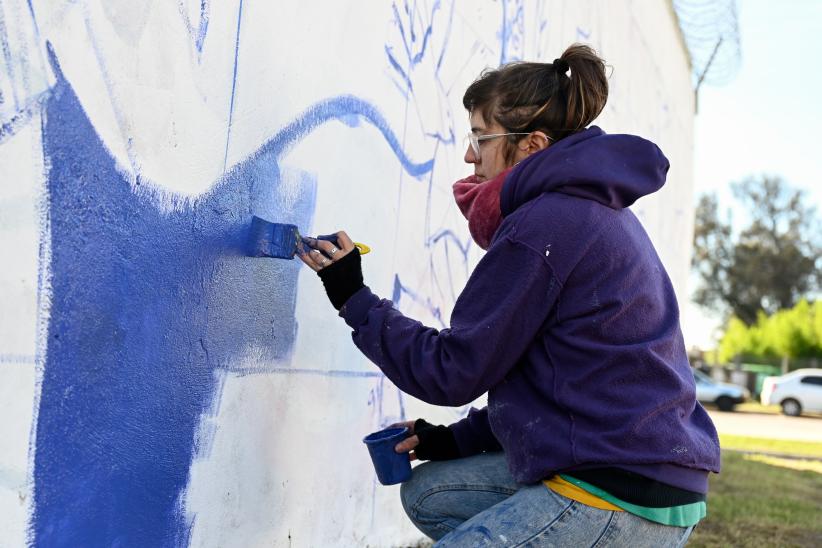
left=682, top=0, right=822, bottom=348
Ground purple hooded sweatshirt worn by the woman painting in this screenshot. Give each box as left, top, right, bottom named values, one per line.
left=340, top=127, right=719, bottom=493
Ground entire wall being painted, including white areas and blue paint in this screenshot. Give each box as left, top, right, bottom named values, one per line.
left=0, top=0, right=716, bottom=546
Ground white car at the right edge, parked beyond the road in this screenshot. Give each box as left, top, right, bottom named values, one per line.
left=760, top=369, right=822, bottom=417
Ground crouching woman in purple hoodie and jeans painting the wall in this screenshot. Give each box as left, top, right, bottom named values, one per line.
left=300, top=44, right=719, bottom=547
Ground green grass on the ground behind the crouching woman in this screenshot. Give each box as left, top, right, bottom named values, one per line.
left=688, top=435, right=822, bottom=548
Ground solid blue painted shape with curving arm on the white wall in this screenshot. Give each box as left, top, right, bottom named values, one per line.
left=31, top=46, right=433, bottom=546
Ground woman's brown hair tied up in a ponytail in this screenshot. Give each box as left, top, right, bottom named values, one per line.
left=462, top=44, right=608, bottom=160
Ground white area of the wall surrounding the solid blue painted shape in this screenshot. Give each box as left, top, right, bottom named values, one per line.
left=0, top=0, right=694, bottom=546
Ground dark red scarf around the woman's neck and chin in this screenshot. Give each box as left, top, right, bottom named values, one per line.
left=453, top=167, right=513, bottom=249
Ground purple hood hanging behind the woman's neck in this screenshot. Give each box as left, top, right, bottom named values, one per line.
left=500, top=126, right=670, bottom=216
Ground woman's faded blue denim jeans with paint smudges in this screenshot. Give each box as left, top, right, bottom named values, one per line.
left=400, top=452, right=693, bottom=548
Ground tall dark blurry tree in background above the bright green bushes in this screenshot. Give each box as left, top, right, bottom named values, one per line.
left=692, top=175, right=822, bottom=325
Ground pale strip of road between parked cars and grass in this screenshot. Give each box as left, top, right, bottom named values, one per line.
left=707, top=409, right=822, bottom=443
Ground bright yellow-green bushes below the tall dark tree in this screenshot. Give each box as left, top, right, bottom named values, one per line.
left=719, top=299, right=822, bottom=362
